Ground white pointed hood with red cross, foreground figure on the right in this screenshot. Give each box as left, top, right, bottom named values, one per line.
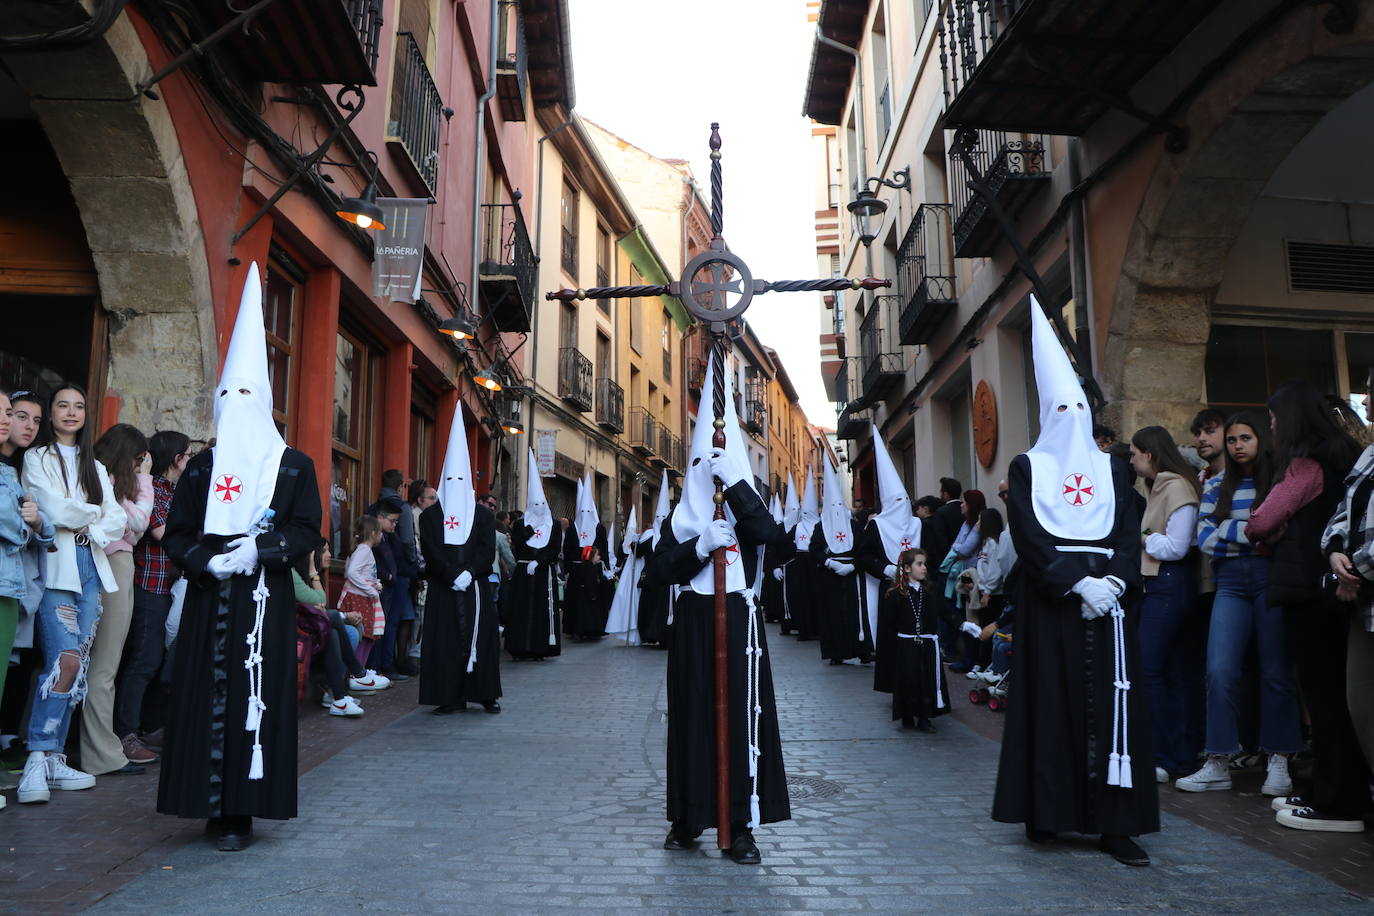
left=1026, top=297, right=1116, bottom=541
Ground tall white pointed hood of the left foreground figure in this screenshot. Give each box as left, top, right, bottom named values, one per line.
left=205, top=261, right=286, bottom=536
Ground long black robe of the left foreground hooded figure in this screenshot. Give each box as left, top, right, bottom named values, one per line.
left=158, top=448, right=323, bottom=820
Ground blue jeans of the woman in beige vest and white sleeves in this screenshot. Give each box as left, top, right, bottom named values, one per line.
left=1138, top=562, right=1197, bottom=776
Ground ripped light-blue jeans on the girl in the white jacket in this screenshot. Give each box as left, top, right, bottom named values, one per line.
left=29, top=547, right=100, bottom=754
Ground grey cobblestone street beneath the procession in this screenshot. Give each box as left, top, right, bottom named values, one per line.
left=0, top=628, right=1341, bottom=913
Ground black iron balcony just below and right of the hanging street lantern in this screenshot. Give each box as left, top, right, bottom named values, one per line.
left=897, top=203, right=959, bottom=343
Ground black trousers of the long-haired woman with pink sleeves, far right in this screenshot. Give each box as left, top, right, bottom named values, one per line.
left=1283, top=600, right=1374, bottom=818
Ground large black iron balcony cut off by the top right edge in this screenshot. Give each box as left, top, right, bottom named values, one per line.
left=927, top=0, right=1220, bottom=136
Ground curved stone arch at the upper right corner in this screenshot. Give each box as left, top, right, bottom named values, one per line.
left=1101, top=0, right=1374, bottom=433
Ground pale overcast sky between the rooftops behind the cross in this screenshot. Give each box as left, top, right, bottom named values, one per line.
left=569, top=0, right=835, bottom=427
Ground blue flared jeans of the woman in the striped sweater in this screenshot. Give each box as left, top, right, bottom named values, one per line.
left=1206, top=556, right=1303, bottom=754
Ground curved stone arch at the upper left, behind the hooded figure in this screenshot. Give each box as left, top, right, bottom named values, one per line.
left=5, top=3, right=218, bottom=439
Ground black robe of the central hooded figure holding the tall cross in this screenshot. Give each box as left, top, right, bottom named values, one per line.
left=650, top=482, right=791, bottom=831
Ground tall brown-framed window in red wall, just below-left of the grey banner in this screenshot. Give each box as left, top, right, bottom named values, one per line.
left=338, top=327, right=382, bottom=562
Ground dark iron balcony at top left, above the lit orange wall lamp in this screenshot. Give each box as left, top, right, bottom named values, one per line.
left=179, top=0, right=382, bottom=87
